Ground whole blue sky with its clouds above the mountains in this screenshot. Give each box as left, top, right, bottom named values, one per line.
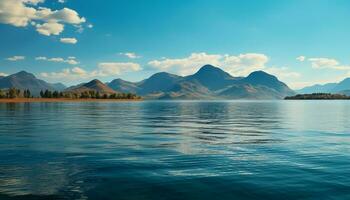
left=0, top=0, right=350, bottom=88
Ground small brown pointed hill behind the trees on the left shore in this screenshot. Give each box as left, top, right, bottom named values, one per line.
left=64, top=79, right=117, bottom=95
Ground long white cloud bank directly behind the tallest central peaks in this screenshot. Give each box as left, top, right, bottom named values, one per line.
left=148, top=53, right=269, bottom=76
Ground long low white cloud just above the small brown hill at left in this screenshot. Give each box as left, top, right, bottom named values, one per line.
left=40, top=62, right=141, bottom=81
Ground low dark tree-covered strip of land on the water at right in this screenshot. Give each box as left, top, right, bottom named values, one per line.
left=284, top=93, right=350, bottom=100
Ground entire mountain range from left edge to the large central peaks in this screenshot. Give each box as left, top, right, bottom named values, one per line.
left=0, top=65, right=295, bottom=99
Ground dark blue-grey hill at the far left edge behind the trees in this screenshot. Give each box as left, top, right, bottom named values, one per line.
left=0, top=71, right=64, bottom=96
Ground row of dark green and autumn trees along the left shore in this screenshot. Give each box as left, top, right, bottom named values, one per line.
left=0, top=88, right=142, bottom=100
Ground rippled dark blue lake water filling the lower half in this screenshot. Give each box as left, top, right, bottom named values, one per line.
left=0, top=101, right=350, bottom=200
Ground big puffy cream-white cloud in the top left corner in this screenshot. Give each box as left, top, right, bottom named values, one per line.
left=0, top=0, right=86, bottom=36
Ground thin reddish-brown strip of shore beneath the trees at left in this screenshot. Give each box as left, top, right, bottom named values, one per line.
left=0, top=98, right=142, bottom=103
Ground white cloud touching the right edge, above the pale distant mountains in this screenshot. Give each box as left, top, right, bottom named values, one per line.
left=308, top=58, right=350, bottom=70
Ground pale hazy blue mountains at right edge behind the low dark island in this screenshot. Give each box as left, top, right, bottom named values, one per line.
left=297, top=78, right=350, bottom=95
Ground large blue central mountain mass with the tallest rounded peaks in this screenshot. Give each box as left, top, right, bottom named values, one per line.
left=108, top=65, right=295, bottom=99
